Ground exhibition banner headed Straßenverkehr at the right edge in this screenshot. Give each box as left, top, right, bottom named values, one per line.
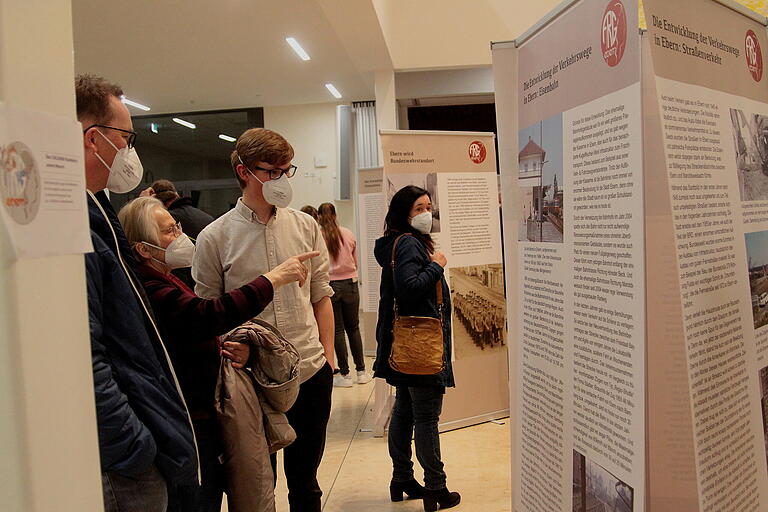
left=644, top=0, right=768, bottom=512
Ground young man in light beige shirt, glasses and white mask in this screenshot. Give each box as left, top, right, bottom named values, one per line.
left=192, top=128, right=334, bottom=512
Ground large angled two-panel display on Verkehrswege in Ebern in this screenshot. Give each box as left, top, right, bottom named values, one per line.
left=493, top=0, right=768, bottom=512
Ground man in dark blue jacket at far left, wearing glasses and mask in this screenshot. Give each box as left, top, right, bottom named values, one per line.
left=75, top=75, right=198, bottom=512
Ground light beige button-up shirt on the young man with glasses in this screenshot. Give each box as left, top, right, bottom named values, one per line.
left=192, top=198, right=333, bottom=382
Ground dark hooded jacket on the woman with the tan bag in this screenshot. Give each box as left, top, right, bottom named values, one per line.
left=373, top=235, right=454, bottom=387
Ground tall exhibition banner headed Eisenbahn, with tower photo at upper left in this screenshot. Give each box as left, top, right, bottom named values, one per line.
left=493, top=0, right=646, bottom=512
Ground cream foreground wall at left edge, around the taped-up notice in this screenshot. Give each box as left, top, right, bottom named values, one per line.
left=0, top=0, right=102, bottom=512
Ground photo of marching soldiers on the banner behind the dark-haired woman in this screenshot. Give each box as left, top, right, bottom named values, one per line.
left=450, top=263, right=506, bottom=359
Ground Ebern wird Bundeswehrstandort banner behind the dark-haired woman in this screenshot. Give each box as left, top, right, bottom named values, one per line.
left=380, top=130, right=509, bottom=430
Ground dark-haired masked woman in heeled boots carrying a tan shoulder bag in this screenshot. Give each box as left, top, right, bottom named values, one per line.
left=374, top=185, right=461, bottom=512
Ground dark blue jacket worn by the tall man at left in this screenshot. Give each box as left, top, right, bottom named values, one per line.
left=85, top=192, right=198, bottom=485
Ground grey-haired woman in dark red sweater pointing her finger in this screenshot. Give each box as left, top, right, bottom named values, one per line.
left=119, top=197, right=319, bottom=512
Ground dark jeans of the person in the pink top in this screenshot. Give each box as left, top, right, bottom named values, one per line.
left=331, top=279, right=365, bottom=375
